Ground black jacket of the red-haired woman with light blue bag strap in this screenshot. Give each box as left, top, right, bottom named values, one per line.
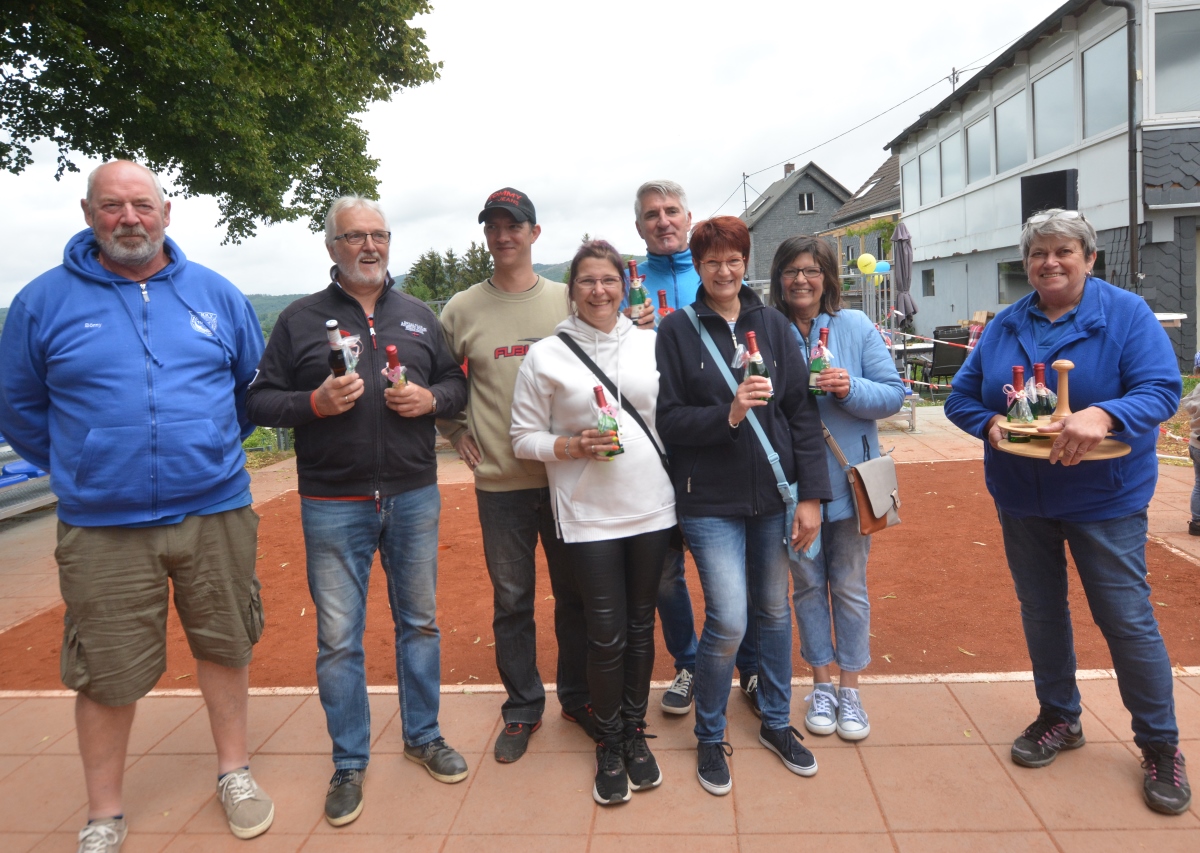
left=655, top=286, right=833, bottom=517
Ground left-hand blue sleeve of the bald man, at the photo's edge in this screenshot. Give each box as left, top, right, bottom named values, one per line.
left=0, top=296, right=50, bottom=471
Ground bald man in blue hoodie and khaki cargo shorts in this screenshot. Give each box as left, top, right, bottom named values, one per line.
left=0, top=161, right=275, bottom=852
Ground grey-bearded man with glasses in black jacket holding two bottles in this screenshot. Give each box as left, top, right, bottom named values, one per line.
left=246, top=196, right=467, bottom=827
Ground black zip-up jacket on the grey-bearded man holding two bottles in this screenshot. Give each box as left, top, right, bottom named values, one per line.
left=246, top=277, right=467, bottom=498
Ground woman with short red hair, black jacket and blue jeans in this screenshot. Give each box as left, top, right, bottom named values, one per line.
left=655, top=216, right=830, bottom=795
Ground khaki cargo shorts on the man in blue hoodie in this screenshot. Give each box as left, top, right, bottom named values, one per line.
left=54, top=506, right=263, bottom=705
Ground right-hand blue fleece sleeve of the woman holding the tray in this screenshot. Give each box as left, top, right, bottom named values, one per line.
left=1092, top=300, right=1183, bottom=435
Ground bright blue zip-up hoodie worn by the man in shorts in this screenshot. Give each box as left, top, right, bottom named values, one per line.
left=0, top=228, right=263, bottom=527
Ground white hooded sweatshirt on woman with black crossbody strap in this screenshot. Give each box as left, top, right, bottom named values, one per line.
left=511, top=316, right=676, bottom=542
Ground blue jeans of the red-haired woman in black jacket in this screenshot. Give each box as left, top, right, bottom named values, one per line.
left=680, top=512, right=792, bottom=744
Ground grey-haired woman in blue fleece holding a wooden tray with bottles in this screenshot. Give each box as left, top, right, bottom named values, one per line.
left=946, top=209, right=1192, bottom=815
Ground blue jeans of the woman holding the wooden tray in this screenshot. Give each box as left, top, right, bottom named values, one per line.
left=1000, top=510, right=1180, bottom=746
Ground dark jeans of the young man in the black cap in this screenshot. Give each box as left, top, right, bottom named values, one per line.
left=475, top=488, right=589, bottom=725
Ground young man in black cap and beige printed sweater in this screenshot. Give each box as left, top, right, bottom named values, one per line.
left=438, top=187, right=592, bottom=763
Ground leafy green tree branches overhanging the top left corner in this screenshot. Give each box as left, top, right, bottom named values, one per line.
left=0, top=0, right=440, bottom=242
